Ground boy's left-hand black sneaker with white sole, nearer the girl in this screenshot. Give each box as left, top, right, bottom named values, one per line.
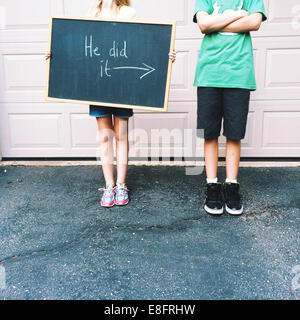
left=204, top=183, right=224, bottom=215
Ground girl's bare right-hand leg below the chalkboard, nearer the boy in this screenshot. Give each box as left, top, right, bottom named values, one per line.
left=114, top=117, right=129, bottom=184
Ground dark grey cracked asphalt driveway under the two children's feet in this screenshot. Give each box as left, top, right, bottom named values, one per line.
left=0, top=166, right=300, bottom=299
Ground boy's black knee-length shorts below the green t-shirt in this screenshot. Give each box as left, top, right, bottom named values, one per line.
left=197, top=87, right=250, bottom=140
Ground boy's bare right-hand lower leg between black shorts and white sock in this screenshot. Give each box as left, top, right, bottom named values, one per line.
left=226, top=139, right=241, bottom=180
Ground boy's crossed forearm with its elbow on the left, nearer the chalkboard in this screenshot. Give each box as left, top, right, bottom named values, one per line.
left=196, top=10, right=248, bottom=33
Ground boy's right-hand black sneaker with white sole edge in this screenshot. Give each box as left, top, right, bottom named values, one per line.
left=224, top=183, right=243, bottom=215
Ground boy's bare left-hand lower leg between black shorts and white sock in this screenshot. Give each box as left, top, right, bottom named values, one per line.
left=204, top=138, right=219, bottom=179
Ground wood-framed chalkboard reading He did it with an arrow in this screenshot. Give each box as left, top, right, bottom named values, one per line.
left=46, top=17, right=175, bottom=112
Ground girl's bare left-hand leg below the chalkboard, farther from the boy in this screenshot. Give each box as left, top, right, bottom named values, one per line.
left=97, top=116, right=115, bottom=186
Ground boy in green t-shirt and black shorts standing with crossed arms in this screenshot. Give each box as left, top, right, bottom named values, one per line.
left=193, top=0, right=267, bottom=215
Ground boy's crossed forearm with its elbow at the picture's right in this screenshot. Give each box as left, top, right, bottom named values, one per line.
left=222, top=12, right=263, bottom=33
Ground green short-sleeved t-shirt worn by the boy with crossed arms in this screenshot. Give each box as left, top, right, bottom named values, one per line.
left=193, top=0, right=267, bottom=90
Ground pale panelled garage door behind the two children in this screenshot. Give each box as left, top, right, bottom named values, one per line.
left=0, top=0, right=300, bottom=158
